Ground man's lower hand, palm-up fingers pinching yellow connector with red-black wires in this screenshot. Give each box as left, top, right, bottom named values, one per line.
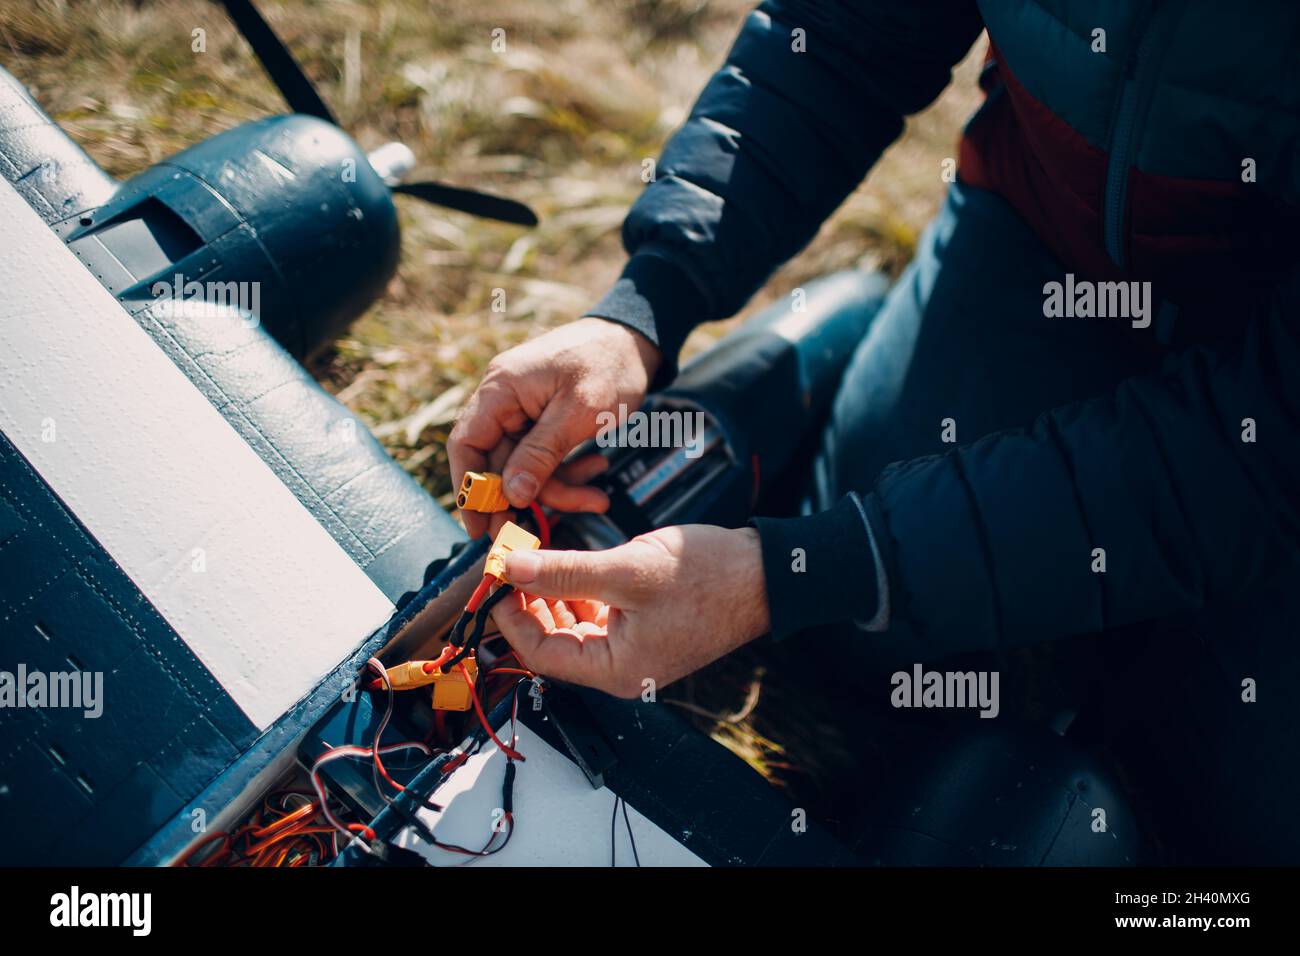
left=493, top=524, right=768, bottom=697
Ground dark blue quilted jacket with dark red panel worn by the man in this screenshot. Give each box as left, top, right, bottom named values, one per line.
left=590, top=0, right=1300, bottom=656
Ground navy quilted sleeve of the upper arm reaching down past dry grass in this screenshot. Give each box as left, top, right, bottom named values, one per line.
left=588, top=0, right=982, bottom=380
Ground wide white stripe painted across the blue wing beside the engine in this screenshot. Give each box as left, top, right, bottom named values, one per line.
left=0, top=182, right=393, bottom=730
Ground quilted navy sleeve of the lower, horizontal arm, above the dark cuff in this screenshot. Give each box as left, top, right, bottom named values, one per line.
left=858, top=282, right=1300, bottom=657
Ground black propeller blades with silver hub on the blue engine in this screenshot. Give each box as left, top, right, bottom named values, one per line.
left=220, top=0, right=537, bottom=226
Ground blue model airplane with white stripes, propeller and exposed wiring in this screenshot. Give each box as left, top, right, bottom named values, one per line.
left=0, top=0, right=1131, bottom=865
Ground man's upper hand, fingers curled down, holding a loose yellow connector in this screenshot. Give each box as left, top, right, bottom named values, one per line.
left=447, top=319, right=660, bottom=537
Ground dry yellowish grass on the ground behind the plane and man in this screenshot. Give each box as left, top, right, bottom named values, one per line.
left=0, top=0, right=978, bottom=837
